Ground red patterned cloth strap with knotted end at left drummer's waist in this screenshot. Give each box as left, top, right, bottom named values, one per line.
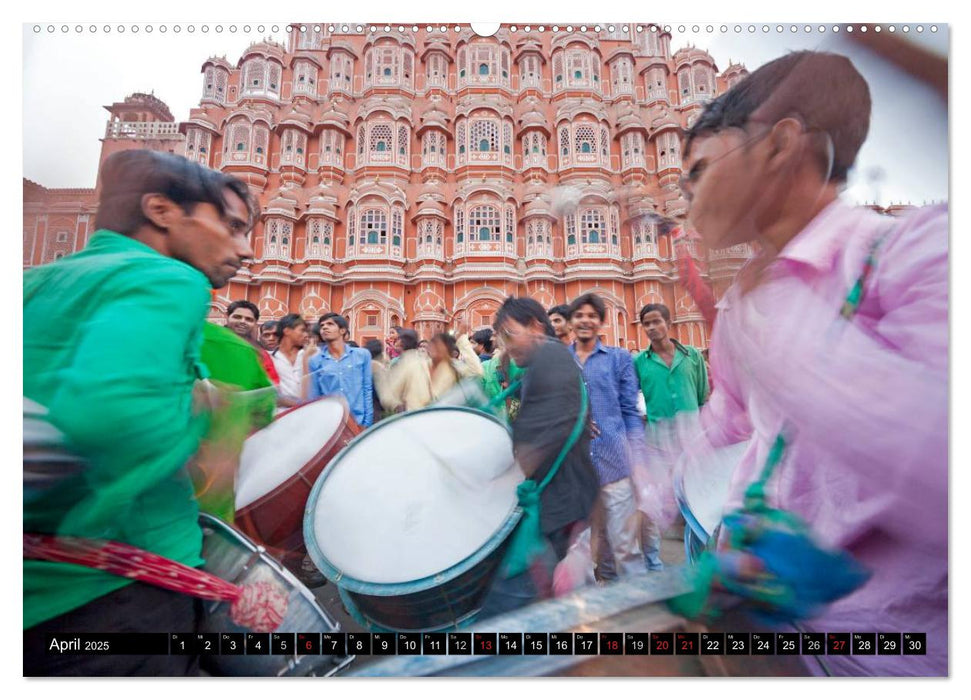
left=24, top=533, right=289, bottom=632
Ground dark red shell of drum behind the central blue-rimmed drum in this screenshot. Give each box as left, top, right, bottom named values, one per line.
left=234, top=397, right=363, bottom=566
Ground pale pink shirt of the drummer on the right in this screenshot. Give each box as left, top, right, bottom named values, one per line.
left=701, top=201, right=948, bottom=675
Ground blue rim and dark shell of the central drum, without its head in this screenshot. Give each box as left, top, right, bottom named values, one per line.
left=304, top=407, right=522, bottom=632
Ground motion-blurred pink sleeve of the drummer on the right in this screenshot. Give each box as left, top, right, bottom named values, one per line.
left=740, top=211, right=948, bottom=542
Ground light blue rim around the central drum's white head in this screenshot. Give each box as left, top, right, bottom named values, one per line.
left=303, top=406, right=523, bottom=596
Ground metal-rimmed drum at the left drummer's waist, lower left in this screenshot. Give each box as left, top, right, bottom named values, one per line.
left=199, top=514, right=354, bottom=676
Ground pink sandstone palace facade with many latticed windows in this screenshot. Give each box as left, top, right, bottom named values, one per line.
left=24, top=24, right=916, bottom=349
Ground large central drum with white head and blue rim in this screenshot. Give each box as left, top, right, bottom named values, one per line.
left=304, top=407, right=523, bottom=631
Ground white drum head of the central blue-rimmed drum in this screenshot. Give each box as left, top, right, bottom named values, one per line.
left=305, top=408, right=523, bottom=583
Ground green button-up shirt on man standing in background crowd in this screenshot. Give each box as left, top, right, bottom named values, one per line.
left=634, top=340, right=708, bottom=423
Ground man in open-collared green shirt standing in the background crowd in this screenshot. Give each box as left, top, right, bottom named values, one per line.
left=634, top=304, right=708, bottom=423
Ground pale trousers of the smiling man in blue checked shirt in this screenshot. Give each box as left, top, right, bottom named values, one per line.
left=590, top=478, right=648, bottom=581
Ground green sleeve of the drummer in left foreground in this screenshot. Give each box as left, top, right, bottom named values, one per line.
left=48, top=262, right=209, bottom=537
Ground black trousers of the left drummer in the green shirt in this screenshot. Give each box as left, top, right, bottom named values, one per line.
left=24, top=582, right=204, bottom=676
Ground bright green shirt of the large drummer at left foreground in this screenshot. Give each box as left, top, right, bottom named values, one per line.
left=23, top=230, right=210, bottom=628
